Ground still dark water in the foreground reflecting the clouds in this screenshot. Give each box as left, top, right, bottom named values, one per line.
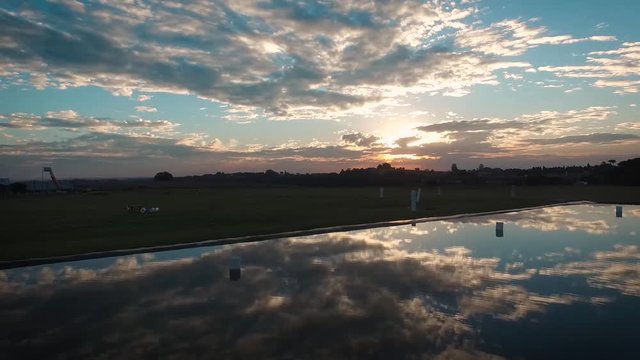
left=0, top=205, right=640, bottom=359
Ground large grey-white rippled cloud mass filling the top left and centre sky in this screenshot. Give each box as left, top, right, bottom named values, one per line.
left=0, top=0, right=530, bottom=119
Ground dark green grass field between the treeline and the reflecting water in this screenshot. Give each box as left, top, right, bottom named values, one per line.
left=0, top=186, right=640, bottom=260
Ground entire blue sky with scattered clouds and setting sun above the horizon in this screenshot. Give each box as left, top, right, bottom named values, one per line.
left=0, top=0, right=640, bottom=179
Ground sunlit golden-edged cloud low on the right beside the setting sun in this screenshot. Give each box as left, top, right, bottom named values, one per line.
left=387, top=106, right=639, bottom=164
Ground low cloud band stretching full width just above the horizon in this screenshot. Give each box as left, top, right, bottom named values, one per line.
left=0, top=102, right=640, bottom=176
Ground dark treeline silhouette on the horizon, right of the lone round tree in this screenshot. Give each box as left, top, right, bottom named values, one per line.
left=175, top=158, right=640, bottom=186
